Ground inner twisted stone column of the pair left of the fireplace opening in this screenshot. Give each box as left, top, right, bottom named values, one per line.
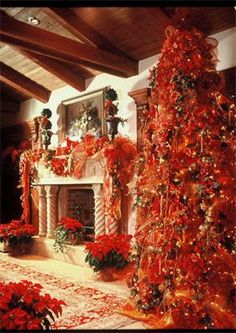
left=45, top=185, right=58, bottom=238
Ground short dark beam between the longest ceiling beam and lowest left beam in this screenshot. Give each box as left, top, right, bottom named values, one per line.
left=16, top=48, right=85, bottom=91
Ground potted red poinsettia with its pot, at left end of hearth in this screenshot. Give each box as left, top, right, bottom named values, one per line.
left=0, top=220, right=36, bottom=255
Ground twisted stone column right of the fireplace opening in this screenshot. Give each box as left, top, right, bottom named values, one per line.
left=92, top=184, right=105, bottom=237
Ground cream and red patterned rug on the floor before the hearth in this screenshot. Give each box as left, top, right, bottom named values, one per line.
left=0, top=257, right=134, bottom=329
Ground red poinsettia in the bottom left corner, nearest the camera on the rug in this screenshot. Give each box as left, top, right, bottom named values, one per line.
left=0, top=280, right=66, bottom=331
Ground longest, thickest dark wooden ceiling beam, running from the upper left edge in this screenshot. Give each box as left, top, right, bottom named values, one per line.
left=0, top=11, right=138, bottom=76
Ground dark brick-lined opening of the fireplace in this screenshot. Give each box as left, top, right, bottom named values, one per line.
left=66, top=188, right=95, bottom=241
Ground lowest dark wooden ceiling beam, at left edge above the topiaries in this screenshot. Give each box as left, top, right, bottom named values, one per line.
left=0, top=62, right=51, bottom=103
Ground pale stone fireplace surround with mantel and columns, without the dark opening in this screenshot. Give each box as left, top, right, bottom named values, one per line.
left=33, top=158, right=106, bottom=238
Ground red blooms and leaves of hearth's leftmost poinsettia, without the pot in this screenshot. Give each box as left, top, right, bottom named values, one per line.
left=0, top=220, right=36, bottom=246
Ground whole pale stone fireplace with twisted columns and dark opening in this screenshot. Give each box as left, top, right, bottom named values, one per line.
left=36, top=159, right=106, bottom=239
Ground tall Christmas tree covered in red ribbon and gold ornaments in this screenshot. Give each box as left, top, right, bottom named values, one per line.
left=124, top=12, right=236, bottom=329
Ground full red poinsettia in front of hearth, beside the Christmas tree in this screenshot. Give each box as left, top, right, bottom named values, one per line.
left=85, top=234, right=132, bottom=272
